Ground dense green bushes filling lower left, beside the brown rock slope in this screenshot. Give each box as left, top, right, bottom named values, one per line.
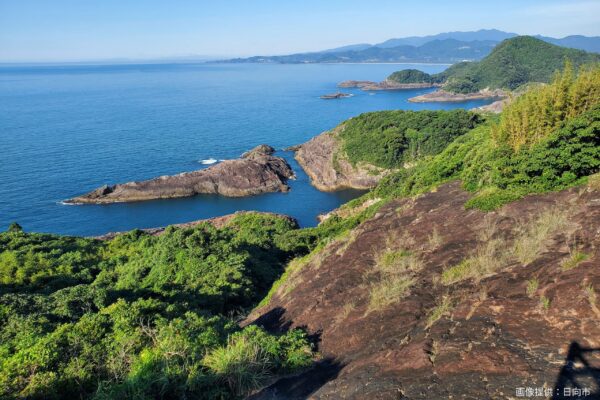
left=0, top=214, right=312, bottom=399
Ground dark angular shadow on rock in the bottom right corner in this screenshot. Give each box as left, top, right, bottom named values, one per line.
left=552, top=342, right=600, bottom=400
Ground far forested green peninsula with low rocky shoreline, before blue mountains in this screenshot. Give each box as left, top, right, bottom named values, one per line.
left=338, top=36, right=600, bottom=108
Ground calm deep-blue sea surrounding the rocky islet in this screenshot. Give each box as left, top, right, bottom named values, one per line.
left=0, top=64, right=494, bottom=235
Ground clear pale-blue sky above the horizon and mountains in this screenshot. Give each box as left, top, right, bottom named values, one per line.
left=0, top=0, right=600, bottom=62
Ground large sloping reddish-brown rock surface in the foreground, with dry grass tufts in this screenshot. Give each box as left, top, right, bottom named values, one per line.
left=247, top=182, right=600, bottom=400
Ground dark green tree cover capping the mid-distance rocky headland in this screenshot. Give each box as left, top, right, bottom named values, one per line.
left=338, top=110, right=483, bottom=168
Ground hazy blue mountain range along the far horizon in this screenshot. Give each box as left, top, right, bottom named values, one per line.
left=220, top=29, right=600, bottom=64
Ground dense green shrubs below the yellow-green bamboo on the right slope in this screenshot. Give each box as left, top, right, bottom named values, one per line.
left=371, top=107, right=600, bottom=210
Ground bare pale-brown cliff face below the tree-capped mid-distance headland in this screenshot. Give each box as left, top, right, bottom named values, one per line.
left=294, top=127, right=387, bottom=192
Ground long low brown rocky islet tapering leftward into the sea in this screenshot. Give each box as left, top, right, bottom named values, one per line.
left=65, top=144, right=295, bottom=204
